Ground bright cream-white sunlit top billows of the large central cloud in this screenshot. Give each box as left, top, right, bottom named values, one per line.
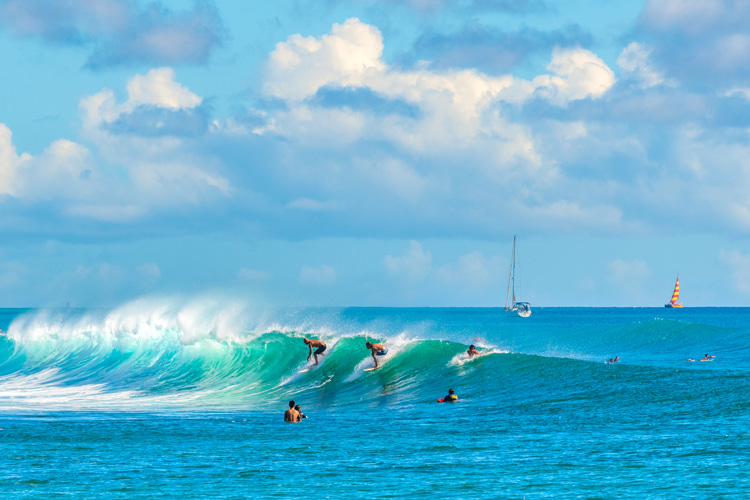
left=264, top=18, right=614, bottom=106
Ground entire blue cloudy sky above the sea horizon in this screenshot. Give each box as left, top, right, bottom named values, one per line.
left=0, top=0, right=750, bottom=307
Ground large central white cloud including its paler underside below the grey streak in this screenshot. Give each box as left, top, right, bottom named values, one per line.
left=263, top=18, right=615, bottom=157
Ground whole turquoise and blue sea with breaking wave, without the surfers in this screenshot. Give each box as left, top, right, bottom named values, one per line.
left=0, top=302, right=750, bottom=499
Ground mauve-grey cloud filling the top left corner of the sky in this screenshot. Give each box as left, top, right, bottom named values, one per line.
left=0, top=0, right=224, bottom=68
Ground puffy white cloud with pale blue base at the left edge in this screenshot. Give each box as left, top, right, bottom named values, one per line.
left=0, top=68, right=230, bottom=222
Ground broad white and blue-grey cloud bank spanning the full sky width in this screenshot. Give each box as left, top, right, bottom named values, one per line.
left=8, top=19, right=750, bottom=246
